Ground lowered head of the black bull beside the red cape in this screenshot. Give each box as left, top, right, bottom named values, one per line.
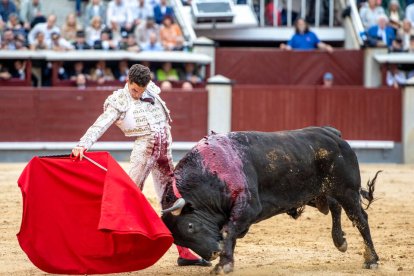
left=162, top=199, right=222, bottom=260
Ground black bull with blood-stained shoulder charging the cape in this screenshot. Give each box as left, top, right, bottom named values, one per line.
left=162, top=127, right=379, bottom=273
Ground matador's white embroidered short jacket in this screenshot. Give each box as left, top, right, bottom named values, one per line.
left=78, top=81, right=171, bottom=149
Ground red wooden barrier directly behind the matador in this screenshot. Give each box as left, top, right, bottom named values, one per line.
left=0, top=87, right=207, bottom=142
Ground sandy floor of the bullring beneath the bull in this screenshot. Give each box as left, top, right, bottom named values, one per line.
left=0, top=163, right=414, bottom=275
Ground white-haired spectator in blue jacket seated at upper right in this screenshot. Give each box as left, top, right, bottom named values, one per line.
left=367, top=14, right=395, bottom=48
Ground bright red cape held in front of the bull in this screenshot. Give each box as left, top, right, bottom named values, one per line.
left=17, top=152, right=173, bottom=274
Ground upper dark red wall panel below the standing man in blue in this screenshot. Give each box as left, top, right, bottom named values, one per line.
left=215, top=48, right=364, bottom=85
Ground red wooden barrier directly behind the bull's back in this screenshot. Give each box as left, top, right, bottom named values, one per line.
left=232, top=85, right=402, bottom=142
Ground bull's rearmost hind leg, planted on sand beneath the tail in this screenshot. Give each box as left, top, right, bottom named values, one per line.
left=340, top=190, right=379, bottom=269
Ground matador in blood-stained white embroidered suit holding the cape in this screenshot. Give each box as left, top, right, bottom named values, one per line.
left=72, top=64, right=211, bottom=266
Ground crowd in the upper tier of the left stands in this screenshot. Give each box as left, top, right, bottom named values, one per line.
left=0, top=0, right=185, bottom=52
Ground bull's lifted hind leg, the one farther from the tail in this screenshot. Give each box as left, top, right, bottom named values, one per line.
left=328, top=197, right=348, bottom=252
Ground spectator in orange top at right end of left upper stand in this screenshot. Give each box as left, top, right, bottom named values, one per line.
left=160, top=16, right=184, bottom=51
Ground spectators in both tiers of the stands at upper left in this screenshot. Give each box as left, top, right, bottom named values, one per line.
left=0, top=0, right=205, bottom=88
